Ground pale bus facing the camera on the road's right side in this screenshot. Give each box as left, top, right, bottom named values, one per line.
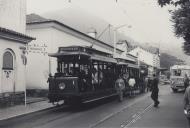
left=170, top=65, right=190, bottom=92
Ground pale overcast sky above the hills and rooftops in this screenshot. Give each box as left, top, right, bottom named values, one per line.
left=27, top=0, right=190, bottom=63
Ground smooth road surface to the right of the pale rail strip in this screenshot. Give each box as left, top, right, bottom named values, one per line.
left=128, top=86, right=188, bottom=128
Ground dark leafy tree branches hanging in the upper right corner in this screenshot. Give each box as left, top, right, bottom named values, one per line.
left=158, top=0, right=190, bottom=55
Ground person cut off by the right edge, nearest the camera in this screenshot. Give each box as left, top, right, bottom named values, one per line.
left=184, top=86, right=190, bottom=128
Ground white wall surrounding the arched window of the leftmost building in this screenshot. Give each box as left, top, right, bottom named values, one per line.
left=0, top=39, right=25, bottom=93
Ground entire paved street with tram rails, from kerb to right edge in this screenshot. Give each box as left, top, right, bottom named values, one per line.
left=0, top=86, right=186, bottom=128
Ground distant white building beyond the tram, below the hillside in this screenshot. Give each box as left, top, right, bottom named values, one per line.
left=129, top=47, right=160, bottom=75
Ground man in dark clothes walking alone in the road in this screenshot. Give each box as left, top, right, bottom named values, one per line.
left=151, top=74, right=160, bottom=107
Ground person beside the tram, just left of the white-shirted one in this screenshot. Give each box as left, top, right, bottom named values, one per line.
left=115, top=75, right=125, bottom=101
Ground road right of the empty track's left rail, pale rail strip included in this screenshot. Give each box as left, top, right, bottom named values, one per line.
left=97, top=85, right=188, bottom=128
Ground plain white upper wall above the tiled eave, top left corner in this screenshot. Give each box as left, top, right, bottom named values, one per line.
left=0, top=0, right=26, bottom=33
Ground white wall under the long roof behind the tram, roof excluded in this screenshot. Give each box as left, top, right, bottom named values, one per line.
left=26, top=27, right=112, bottom=89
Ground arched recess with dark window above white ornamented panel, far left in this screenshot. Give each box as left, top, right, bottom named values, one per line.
left=2, top=49, right=15, bottom=93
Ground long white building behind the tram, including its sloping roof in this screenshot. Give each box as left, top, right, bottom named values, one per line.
left=26, top=14, right=122, bottom=90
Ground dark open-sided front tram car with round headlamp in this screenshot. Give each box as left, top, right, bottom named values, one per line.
left=48, top=46, right=141, bottom=105
